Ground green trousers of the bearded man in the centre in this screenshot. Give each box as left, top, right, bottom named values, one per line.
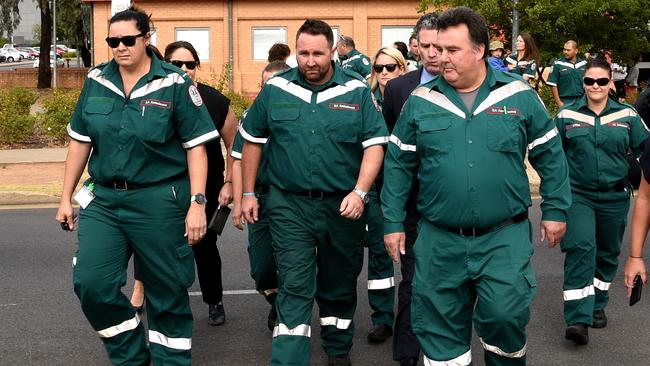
left=267, top=186, right=367, bottom=365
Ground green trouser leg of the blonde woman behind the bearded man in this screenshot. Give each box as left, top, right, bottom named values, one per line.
left=366, top=188, right=395, bottom=327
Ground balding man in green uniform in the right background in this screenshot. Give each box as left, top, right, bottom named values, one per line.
left=546, top=40, right=587, bottom=108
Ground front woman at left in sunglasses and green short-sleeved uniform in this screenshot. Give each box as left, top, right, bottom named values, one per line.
left=56, top=8, right=219, bottom=365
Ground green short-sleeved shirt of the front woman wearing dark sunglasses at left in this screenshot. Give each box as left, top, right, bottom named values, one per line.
left=68, top=57, right=219, bottom=184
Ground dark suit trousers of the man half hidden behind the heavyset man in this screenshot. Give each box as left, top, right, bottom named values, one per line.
left=393, top=189, right=422, bottom=361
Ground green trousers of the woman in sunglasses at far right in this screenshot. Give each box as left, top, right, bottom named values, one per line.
left=560, top=191, right=630, bottom=325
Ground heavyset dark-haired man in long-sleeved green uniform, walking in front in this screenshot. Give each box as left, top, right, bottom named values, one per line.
left=381, top=7, right=570, bottom=365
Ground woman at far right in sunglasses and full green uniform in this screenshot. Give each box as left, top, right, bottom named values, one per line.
left=556, top=59, right=649, bottom=345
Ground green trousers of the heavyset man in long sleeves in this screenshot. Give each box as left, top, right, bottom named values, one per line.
left=411, top=219, right=536, bottom=366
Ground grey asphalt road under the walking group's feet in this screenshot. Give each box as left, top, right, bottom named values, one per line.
left=0, top=202, right=650, bottom=366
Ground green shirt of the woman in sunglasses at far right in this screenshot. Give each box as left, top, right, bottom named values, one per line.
left=555, top=96, right=649, bottom=194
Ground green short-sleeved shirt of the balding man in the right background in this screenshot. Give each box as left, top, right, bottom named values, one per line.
left=546, top=57, right=587, bottom=98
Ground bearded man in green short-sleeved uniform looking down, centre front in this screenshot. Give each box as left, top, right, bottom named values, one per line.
left=239, top=19, right=387, bottom=365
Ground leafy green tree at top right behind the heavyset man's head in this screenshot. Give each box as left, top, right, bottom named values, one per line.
left=418, top=0, right=650, bottom=62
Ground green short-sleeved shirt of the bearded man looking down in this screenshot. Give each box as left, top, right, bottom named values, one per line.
left=239, top=62, right=388, bottom=192
